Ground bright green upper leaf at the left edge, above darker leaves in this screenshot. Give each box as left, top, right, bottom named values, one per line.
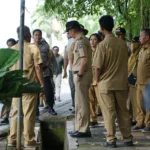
left=0, top=48, right=20, bottom=71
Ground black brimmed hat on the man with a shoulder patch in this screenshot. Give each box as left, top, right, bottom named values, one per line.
left=64, top=20, right=81, bottom=33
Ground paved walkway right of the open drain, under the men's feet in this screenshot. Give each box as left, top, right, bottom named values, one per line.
left=65, top=121, right=150, bottom=150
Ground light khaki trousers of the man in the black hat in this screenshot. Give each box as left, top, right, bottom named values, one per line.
left=74, top=72, right=92, bottom=132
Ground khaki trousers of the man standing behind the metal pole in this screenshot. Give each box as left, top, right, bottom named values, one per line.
left=8, top=94, right=38, bottom=145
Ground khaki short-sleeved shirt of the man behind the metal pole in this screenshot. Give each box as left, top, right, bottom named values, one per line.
left=11, top=41, right=42, bottom=81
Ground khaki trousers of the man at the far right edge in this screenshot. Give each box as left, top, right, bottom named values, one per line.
left=136, top=84, right=150, bottom=127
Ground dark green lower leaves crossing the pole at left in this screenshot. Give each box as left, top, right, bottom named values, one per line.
left=0, top=70, right=42, bottom=99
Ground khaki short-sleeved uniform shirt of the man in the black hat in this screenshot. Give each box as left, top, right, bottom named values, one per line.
left=71, top=34, right=92, bottom=72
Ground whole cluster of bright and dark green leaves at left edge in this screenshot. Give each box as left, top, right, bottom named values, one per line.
left=0, top=49, right=41, bottom=104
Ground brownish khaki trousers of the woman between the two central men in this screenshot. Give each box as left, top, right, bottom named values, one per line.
left=89, top=85, right=100, bottom=122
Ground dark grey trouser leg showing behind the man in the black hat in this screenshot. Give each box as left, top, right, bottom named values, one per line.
left=69, top=70, right=75, bottom=107
